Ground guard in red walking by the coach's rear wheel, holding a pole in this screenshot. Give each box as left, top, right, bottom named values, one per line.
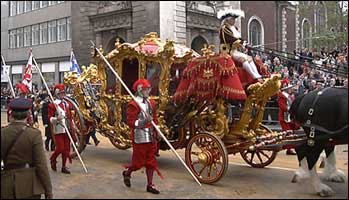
left=48, top=84, right=74, bottom=174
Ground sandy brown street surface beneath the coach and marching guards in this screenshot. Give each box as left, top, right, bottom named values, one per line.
left=1, top=112, right=348, bottom=199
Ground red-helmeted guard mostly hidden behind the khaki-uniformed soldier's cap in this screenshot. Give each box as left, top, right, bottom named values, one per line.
left=7, top=83, right=34, bottom=126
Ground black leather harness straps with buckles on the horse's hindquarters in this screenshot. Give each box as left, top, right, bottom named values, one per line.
left=305, top=87, right=348, bottom=147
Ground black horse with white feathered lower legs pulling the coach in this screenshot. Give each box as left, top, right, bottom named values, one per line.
left=289, top=87, right=348, bottom=197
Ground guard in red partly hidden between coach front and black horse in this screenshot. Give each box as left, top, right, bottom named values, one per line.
left=278, top=78, right=298, bottom=155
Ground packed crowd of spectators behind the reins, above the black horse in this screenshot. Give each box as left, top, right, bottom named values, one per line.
left=250, top=44, right=348, bottom=96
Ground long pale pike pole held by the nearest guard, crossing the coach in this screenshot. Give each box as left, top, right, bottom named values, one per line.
left=90, top=40, right=201, bottom=186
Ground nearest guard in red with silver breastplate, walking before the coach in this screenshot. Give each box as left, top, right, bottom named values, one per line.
left=122, top=79, right=162, bottom=194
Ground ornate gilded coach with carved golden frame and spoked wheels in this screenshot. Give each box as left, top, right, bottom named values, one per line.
left=65, top=32, right=280, bottom=183
